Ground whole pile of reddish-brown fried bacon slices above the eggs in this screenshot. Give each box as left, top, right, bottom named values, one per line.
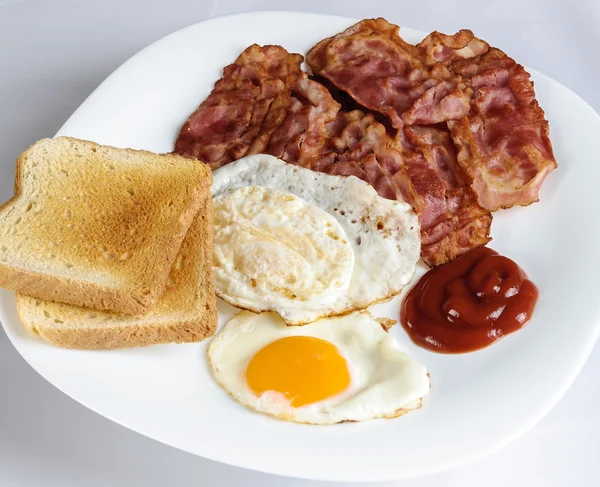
left=175, top=18, right=556, bottom=266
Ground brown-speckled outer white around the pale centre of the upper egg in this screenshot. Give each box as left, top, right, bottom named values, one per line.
left=211, top=154, right=421, bottom=325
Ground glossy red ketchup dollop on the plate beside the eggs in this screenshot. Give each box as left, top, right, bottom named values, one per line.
left=400, top=247, right=538, bottom=353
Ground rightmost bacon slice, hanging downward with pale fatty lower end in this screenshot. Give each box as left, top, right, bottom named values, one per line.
left=448, top=48, right=556, bottom=211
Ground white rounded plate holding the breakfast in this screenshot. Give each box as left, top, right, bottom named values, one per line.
left=0, top=12, right=600, bottom=481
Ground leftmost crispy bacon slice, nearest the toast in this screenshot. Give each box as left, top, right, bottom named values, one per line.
left=175, top=44, right=303, bottom=168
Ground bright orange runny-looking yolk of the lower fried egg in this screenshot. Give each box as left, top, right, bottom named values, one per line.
left=246, top=336, right=350, bottom=407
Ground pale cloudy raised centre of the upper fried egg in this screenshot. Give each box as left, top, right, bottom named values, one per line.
left=213, top=186, right=354, bottom=317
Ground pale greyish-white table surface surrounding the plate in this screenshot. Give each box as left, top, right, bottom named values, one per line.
left=0, top=0, right=600, bottom=487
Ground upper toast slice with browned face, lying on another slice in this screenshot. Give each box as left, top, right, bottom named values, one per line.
left=0, top=137, right=212, bottom=314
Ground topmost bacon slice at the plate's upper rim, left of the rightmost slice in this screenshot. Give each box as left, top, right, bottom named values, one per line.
left=306, top=18, right=469, bottom=129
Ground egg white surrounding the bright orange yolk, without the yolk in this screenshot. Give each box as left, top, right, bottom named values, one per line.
left=208, top=311, right=429, bottom=424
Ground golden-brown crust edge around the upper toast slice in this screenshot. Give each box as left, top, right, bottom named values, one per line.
left=0, top=137, right=212, bottom=314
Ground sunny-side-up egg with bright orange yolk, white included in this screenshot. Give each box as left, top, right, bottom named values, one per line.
left=208, top=311, right=429, bottom=424
